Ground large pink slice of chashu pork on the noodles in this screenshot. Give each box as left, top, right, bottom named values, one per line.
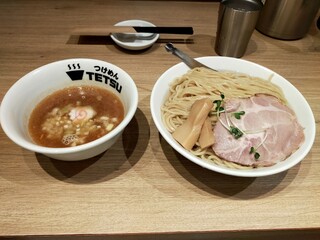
left=212, top=94, right=304, bottom=167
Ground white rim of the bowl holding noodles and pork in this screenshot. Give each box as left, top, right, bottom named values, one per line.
left=150, top=56, right=316, bottom=177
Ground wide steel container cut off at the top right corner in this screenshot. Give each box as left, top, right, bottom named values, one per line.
left=256, top=0, right=320, bottom=40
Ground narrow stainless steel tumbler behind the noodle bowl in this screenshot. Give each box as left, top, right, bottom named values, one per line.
left=215, top=0, right=263, bottom=57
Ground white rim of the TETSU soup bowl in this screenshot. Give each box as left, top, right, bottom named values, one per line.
left=0, top=58, right=138, bottom=155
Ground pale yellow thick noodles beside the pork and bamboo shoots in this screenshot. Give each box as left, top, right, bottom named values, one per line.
left=161, top=68, right=286, bottom=169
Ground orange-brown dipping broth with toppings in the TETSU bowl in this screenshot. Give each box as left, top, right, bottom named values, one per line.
left=28, top=86, right=124, bottom=148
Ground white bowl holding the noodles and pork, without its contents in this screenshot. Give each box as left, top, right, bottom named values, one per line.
left=150, top=57, right=316, bottom=177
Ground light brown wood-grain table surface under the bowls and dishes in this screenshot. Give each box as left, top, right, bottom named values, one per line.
left=0, top=0, right=320, bottom=239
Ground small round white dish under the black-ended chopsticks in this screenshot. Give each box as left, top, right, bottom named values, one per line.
left=110, top=20, right=159, bottom=50
